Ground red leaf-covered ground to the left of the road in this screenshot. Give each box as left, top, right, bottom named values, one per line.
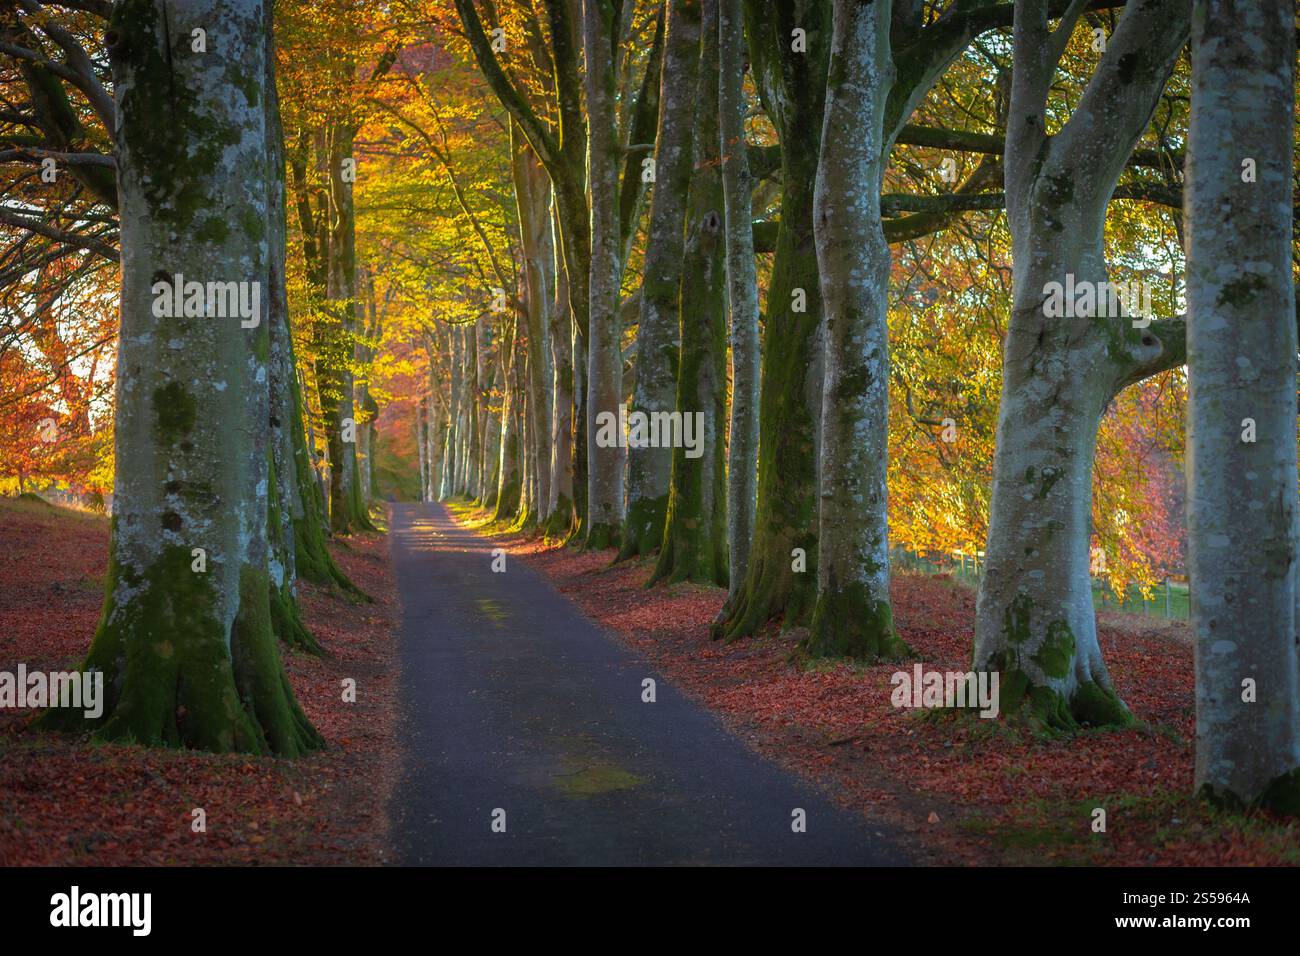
left=0, top=499, right=397, bottom=866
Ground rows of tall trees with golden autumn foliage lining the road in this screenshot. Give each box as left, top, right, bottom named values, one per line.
left=0, top=0, right=1300, bottom=813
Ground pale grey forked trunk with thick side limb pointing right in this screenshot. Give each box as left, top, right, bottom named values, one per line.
left=975, top=0, right=1190, bottom=730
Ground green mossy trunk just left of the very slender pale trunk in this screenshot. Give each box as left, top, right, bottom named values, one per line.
left=651, top=0, right=727, bottom=585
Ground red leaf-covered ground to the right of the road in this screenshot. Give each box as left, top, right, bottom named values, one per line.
left=454, top=505, right=1300, bottom=866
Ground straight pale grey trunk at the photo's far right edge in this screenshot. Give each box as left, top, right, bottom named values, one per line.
left=1186, top=0, right=1300, bottom=814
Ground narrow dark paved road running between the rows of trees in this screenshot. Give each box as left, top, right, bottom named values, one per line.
left=391, top=505, right=906, bottom=865
